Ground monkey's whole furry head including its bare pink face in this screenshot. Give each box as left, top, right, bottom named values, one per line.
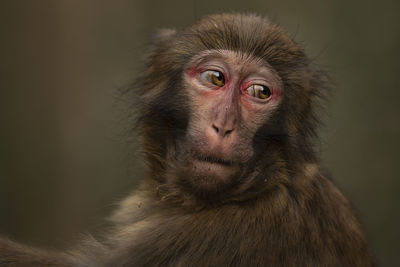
left=138, top=14, right=323, bottom=206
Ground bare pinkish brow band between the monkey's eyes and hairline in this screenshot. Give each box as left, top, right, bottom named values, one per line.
left=184, top=49, right=282, bottom=86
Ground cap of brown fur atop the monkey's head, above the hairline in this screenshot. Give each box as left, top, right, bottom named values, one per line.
left=177, top=13, right=306, bottom=68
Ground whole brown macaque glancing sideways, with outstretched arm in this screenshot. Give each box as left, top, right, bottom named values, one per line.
left=0, top=14, right=374, bottom=267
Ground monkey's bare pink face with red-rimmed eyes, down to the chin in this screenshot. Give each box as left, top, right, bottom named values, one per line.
left=173, top=50, right=283, bottom=193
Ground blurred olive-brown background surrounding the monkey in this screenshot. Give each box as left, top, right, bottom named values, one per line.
left=0, top=0, right=400, bottom=266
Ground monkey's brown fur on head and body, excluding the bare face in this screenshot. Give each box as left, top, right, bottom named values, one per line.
left=0, top=14, right=373, bottom=267
